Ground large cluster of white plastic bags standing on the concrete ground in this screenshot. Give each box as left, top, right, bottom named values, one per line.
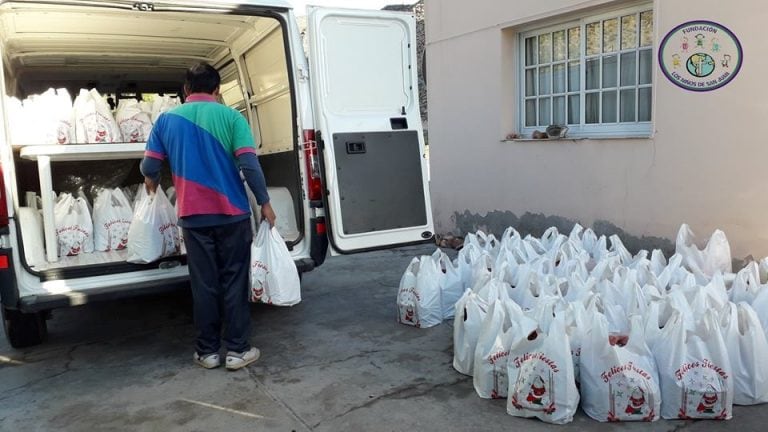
left=398, top=225, right=768, bottom=423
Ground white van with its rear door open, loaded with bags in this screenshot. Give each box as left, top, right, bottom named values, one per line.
left=0, top=0, right=433, bottom=347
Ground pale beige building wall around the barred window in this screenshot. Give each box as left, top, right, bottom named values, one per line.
left=426, top=0, right=768, bottom=258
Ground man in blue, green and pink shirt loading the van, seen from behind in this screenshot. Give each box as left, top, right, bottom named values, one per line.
left=141, top=63, right=275, bottom=370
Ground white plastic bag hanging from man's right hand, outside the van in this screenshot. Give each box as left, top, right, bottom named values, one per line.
left=250, top=220, right=301, bottom=306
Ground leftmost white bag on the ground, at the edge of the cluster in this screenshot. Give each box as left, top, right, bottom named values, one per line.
left=397, top=255, right=443, bottom=328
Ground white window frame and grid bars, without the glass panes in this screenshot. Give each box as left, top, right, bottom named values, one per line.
left=516, top=2, right=657, bottom=138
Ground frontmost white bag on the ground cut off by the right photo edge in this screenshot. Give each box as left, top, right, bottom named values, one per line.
left=720, top=302, right=768, bottom=405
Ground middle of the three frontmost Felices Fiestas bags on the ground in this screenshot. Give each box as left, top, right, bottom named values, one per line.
left=580, top=313, right=661, bottom=422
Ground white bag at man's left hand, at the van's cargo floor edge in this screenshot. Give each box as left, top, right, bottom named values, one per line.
left=127, top=187, right=179, bottom=263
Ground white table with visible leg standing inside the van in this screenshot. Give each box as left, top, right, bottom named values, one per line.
left=19, top=143, right=146, bottom=262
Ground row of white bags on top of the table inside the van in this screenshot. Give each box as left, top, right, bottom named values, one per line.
left=6, top=88, right=180, bottom=146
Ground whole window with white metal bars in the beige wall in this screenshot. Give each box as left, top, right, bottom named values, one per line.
left=519, top=5, right=654, bottom=137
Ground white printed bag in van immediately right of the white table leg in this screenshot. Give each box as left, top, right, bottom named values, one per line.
left=53, top=193, right=93, bottom=257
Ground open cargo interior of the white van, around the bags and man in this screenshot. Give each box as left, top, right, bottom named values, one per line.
left=0, top=1, right=308, bottom=281
